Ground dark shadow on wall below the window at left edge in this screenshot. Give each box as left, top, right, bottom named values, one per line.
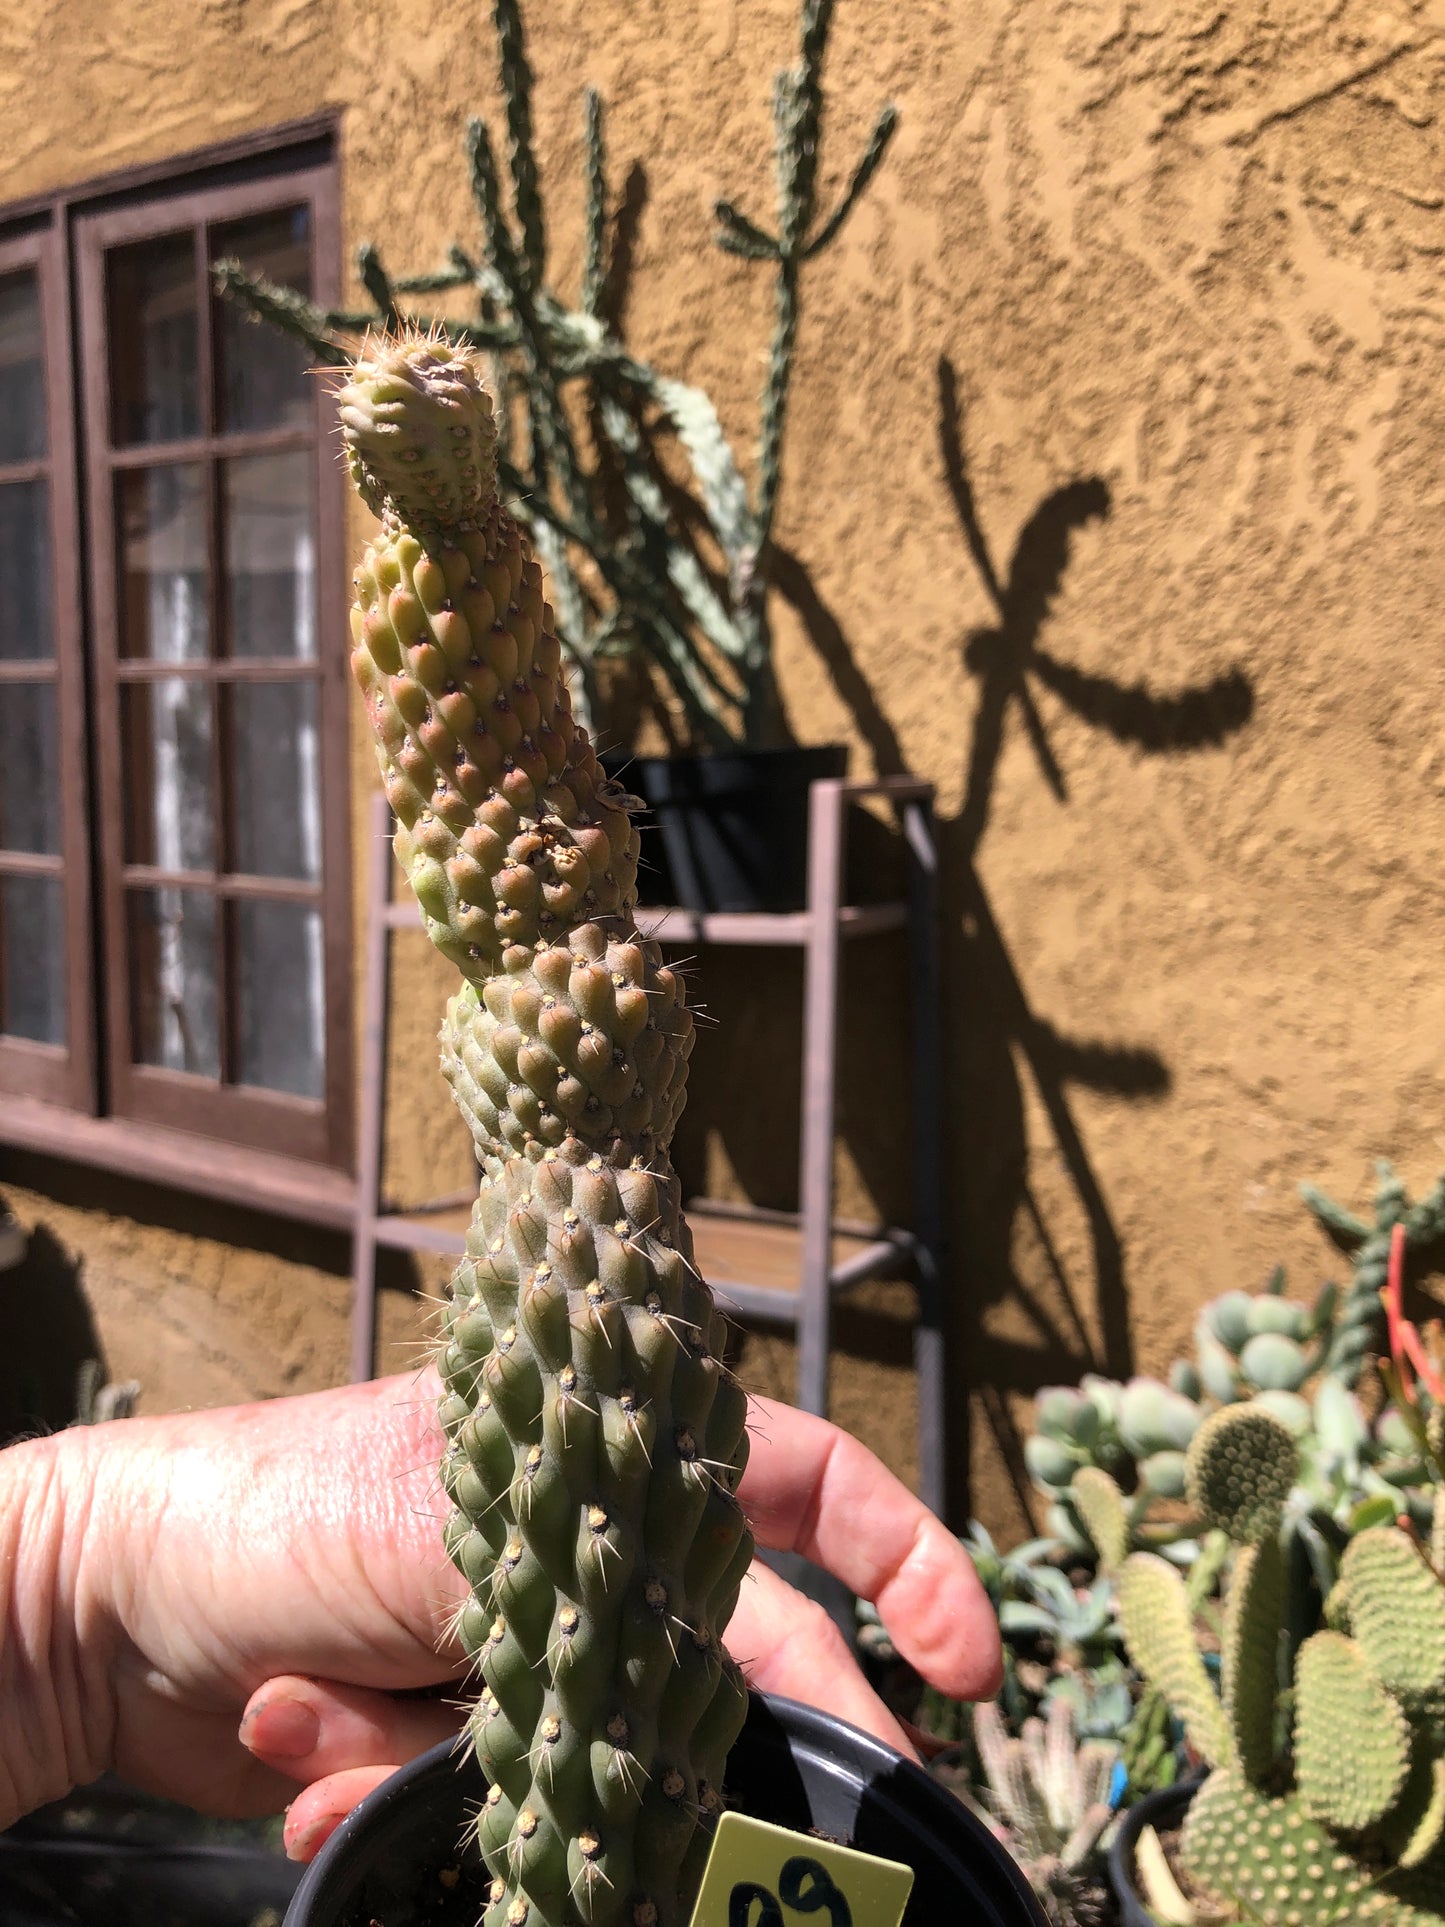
left=0, top=1199, right=100, bottom=1445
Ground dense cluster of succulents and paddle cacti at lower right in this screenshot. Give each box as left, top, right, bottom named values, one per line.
left=859, top=1166, right=1445, bottom=1927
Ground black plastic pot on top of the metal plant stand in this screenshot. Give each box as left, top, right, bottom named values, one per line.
left=620, top=744, right=848, bottom=911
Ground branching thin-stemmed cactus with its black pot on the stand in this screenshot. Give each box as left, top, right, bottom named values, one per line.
left=220, top=0, right=896, bottom=910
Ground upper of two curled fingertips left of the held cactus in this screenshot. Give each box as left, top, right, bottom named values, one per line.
left=241, top=1675, right=460, bottom=1782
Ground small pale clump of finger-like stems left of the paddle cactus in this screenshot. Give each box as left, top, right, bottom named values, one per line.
left=973, top=1698, right=1119, bottom=1927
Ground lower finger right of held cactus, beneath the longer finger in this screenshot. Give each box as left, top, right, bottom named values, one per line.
left=724, top=1561, right=913, bottom=1755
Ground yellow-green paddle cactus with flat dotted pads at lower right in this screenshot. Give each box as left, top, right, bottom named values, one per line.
left=1119, top=1405, right=1445, bottom=1927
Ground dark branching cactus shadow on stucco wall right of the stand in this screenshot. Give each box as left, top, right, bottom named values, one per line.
left=751, top=358, right=1254, bottom=1505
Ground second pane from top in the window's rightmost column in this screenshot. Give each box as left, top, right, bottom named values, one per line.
left=222, top=449, right=316, bottom=661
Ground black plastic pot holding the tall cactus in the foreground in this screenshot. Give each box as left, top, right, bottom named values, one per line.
left=285, top=1694, right=1044, bottom=1927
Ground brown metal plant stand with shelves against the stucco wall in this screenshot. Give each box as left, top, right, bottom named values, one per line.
left=353, top=777, right=946, bottom=1513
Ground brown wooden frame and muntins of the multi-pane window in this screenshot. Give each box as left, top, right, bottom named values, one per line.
left=0, top=119, right=355, bottom=1172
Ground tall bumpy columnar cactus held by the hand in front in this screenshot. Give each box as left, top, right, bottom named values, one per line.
left=339, top=333, right=751, bottom=1927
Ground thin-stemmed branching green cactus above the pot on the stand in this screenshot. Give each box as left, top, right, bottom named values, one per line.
left=216, top=0, right=898, bottom=748
